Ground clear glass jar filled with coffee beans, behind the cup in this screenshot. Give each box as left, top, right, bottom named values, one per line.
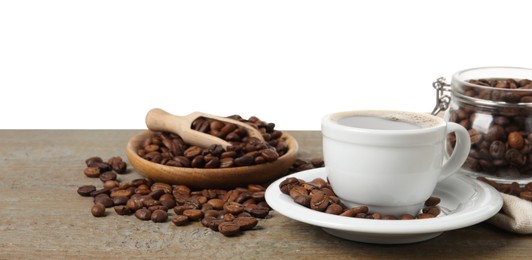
left=444, top=67, right=532, bottom=184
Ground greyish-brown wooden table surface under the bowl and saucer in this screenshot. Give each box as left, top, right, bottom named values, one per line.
left=0, top=130, right=532, bottom=259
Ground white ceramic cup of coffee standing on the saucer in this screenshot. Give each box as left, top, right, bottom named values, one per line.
left=321, top=110, right=471, bottom=216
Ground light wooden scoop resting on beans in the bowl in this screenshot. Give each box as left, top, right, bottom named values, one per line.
left=146, top=108, right=264, bottom=149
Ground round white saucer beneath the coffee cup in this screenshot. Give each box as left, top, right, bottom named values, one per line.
left=266, top=168, right=503, bottom=244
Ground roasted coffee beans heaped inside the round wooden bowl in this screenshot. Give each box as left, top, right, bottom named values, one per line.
left=137, top=115, right=288, bottom=168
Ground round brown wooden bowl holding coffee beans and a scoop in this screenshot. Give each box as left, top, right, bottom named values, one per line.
left=126, top=130, right=299, bottom=189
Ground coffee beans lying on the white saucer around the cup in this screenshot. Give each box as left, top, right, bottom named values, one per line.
left=279, top=177, right=441, bottom=220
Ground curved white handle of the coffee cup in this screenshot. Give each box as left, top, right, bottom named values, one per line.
left=438, top=122, right=471, bottom=182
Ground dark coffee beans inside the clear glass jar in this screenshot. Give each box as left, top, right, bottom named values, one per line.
left=448, top=79, right=532, bottom=179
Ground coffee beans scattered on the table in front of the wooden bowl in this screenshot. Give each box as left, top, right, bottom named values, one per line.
left=77, top=157, right=271, bottom=236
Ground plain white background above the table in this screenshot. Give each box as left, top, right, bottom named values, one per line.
left=0, top=0, right=532, bottom=130
